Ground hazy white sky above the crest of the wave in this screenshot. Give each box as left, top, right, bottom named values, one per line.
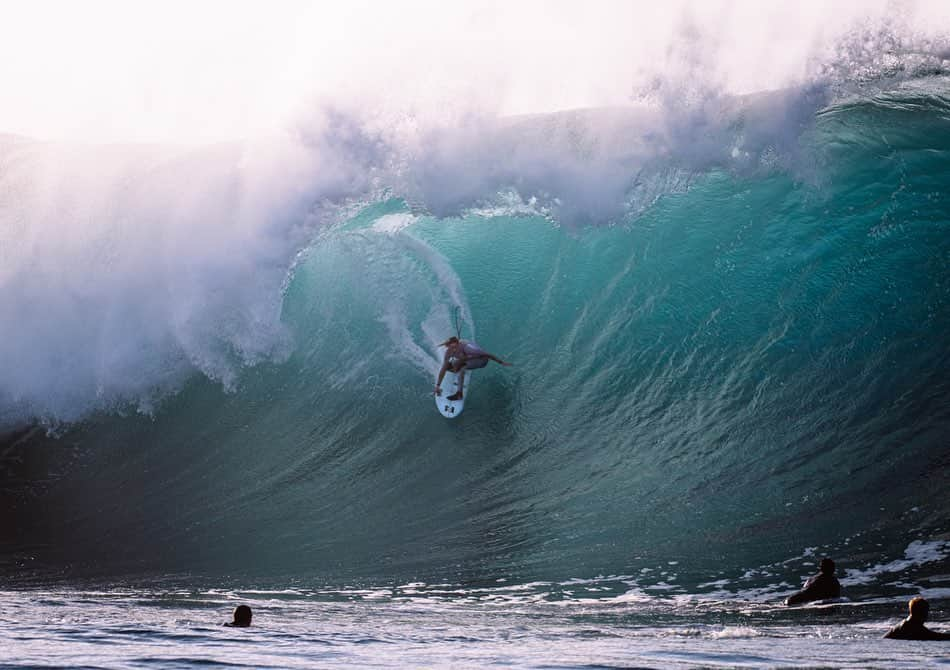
left=0, top=0, right=950, bottom=141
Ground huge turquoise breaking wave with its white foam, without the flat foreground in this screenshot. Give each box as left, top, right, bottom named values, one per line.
left=0, top=77, right=950, bottom=583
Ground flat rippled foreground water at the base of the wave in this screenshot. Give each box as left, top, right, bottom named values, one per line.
left=0, top=577, right=950, bottom=668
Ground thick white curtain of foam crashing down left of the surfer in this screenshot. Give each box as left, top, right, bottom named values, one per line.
left=0, top=143, right=313, bottom=424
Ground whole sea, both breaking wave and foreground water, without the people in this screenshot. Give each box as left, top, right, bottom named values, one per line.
left=0, top=30, right=950, bottom=668
